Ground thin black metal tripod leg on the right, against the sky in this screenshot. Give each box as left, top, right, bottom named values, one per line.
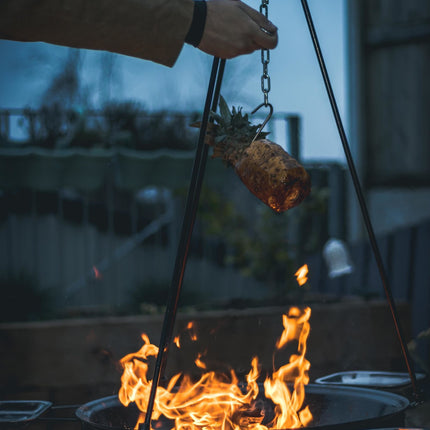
left=301, top=0, right=419, bottom=398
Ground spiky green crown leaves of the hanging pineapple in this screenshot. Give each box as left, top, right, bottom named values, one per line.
left=211, top=96, right=269, bottom=144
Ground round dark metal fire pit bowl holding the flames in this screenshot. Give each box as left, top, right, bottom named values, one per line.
left=76, top=384, right=409, bottom=430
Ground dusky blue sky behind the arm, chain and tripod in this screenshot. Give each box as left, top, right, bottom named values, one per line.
left=0, top=0, right=347, bottom=161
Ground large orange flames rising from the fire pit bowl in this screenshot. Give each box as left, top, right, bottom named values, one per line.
left=119, top=308, right=312, bottom=430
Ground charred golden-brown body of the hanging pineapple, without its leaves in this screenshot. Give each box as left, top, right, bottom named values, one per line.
left=230, top=139, right=311, bottom=213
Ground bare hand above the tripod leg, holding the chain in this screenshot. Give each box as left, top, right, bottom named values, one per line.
left=198, top=0, right=278, bottom=59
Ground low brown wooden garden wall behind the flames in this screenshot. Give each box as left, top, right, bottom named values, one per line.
left=0, top=300, right=410, bottom=404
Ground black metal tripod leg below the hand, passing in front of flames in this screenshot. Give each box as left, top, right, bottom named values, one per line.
left=143, top=58, right=225, bottom=430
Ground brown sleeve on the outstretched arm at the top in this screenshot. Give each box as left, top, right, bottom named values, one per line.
left=0, top=0, right=194, bottom=66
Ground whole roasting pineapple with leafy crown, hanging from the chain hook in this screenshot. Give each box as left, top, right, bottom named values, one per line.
left=206, top=97, right=311, bottom=212
